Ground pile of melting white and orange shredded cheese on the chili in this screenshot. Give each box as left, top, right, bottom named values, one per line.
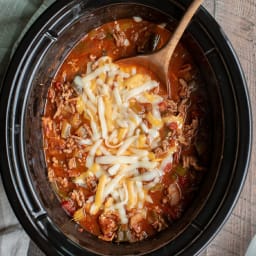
left=74, top=56, right=183, bottom=218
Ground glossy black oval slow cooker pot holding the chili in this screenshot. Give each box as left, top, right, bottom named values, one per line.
left=0, top=0, right=251, bottom=255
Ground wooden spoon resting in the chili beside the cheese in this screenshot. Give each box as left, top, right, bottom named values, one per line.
left=117, top=0, right=203, bottom=97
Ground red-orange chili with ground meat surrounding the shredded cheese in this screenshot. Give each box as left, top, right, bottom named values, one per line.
left=42, top=18, right=210, bottom=242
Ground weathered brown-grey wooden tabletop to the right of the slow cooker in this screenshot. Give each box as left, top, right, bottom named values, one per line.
left=200, top=0, right=256, bottom=256
